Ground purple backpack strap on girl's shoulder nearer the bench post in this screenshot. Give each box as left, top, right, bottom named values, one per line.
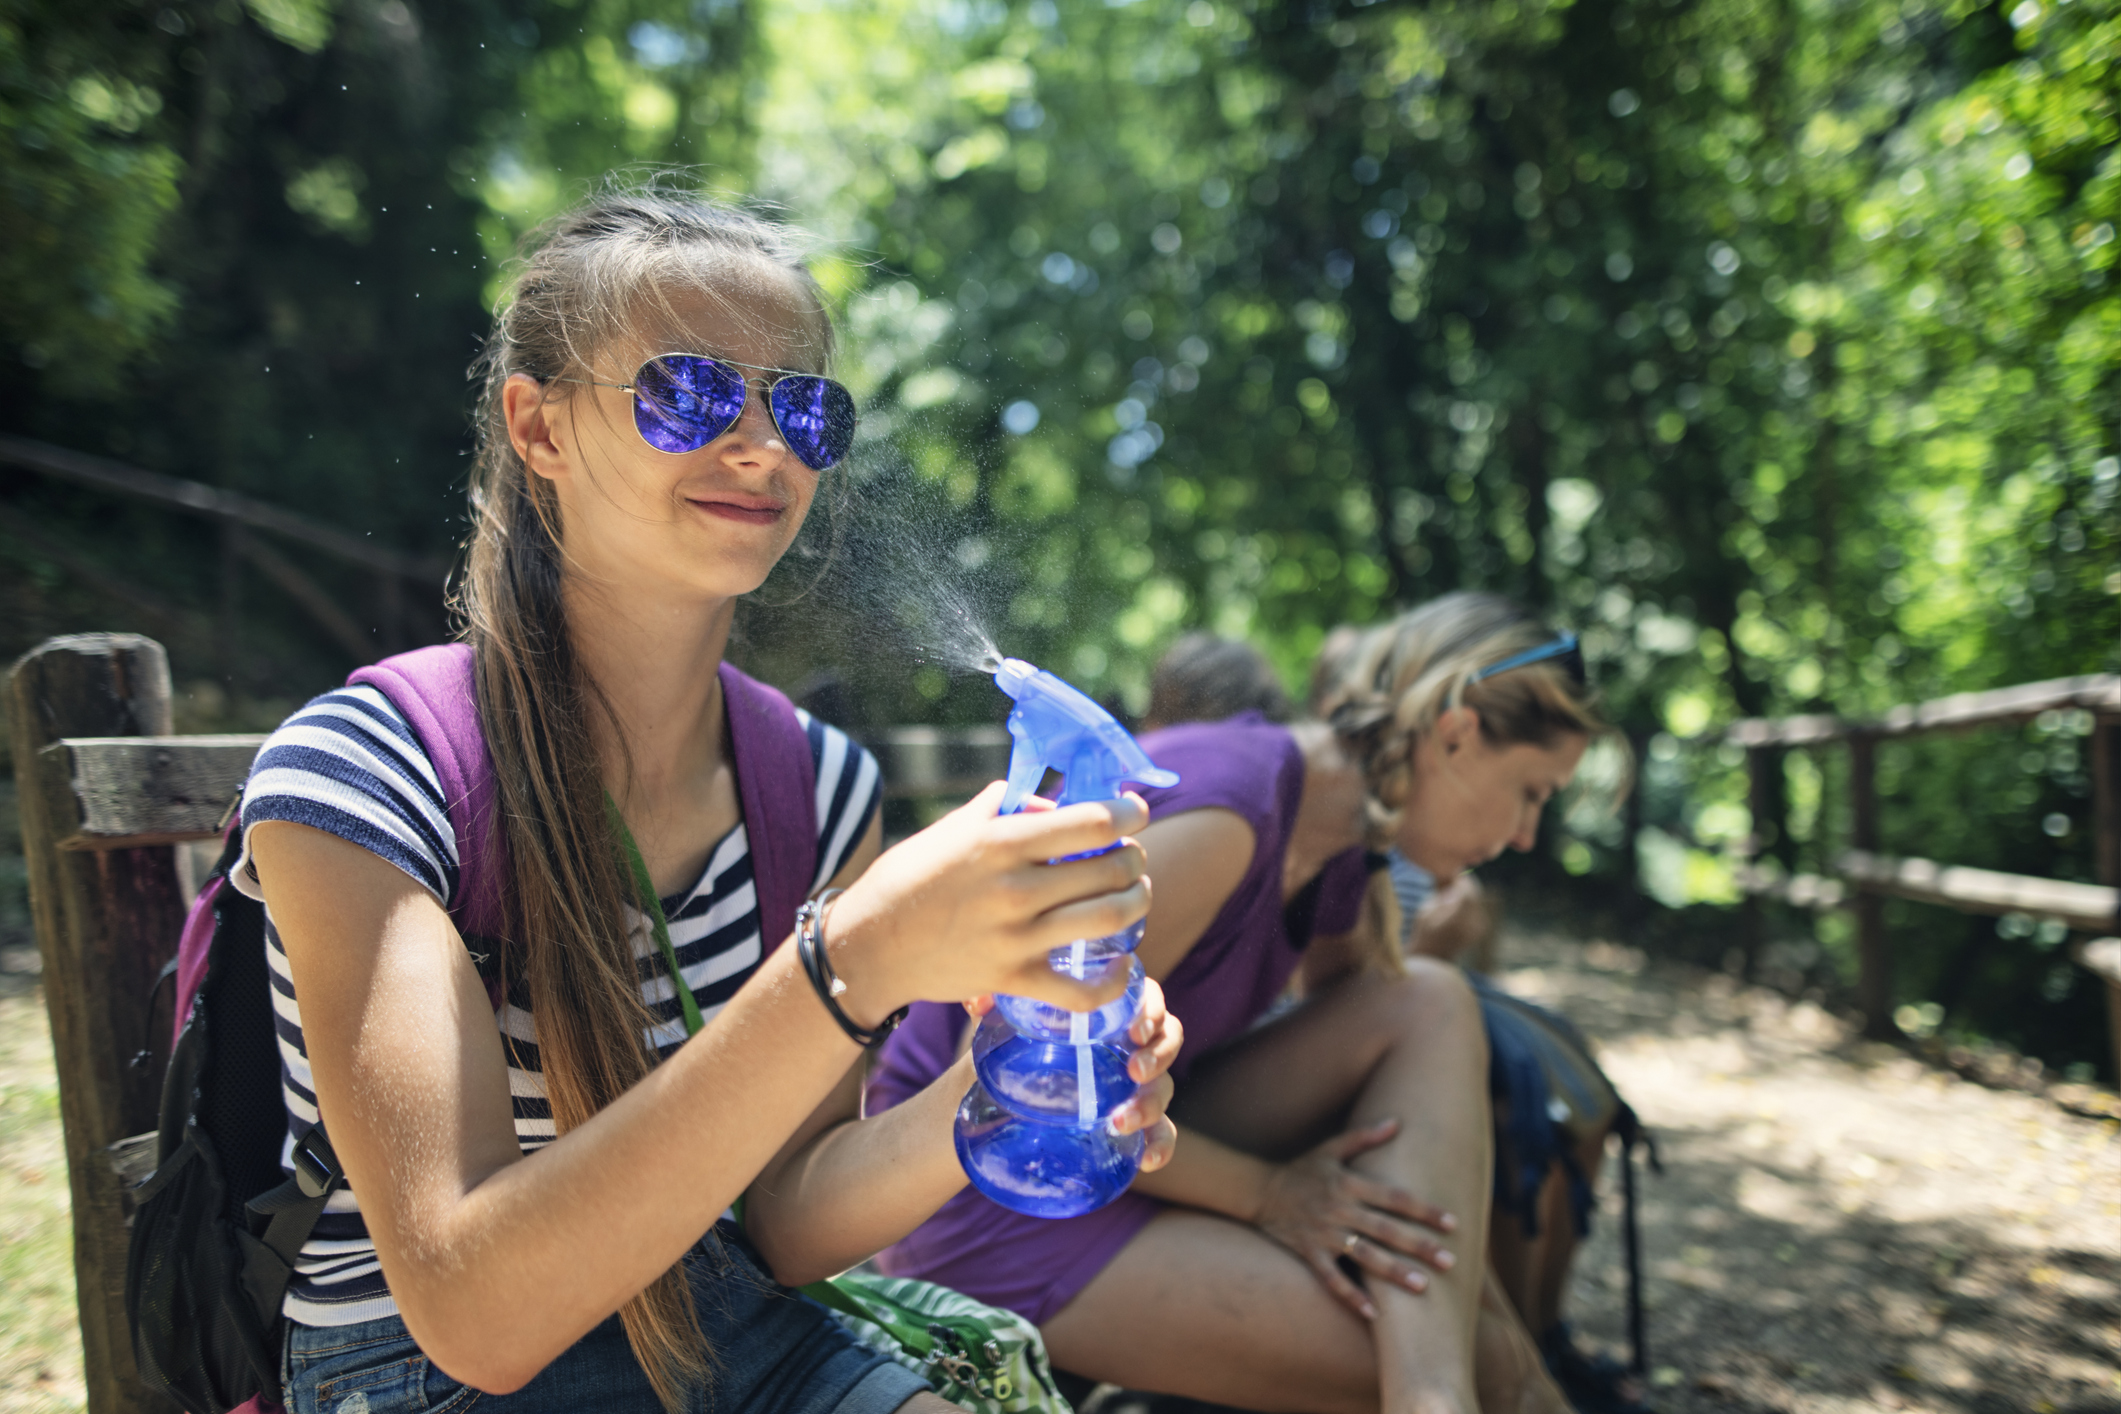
left=346, top=642, right=503, bottom=937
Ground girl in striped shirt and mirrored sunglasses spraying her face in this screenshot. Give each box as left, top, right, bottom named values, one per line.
left=240, top=191, right=1177, bottom=1414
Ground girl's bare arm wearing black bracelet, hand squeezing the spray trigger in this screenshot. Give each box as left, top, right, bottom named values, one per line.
left=269, top=784, right=1147, bottom=1391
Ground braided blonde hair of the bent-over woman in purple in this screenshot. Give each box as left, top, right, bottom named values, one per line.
left=1311, top=594, right=1612, bottom=848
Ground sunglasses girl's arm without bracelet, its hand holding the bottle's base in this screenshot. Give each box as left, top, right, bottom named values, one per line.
left=744, top=805, right=1179, bottom=1287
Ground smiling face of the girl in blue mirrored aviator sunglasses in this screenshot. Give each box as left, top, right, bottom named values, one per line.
left=503, top=261, right=825, bottom=611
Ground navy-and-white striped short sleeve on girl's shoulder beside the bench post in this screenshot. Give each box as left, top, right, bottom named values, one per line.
left=229, top=687, right=458, bottom=907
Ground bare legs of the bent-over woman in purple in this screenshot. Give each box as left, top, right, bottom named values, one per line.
left=1046, top=958, right=1557, bottom=1414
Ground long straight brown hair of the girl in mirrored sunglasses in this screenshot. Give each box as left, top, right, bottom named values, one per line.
left=456, top=182, right=831, bottom=1410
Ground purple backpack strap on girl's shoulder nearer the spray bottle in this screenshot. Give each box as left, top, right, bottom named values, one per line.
left=721, top=664, right=817, bottom=952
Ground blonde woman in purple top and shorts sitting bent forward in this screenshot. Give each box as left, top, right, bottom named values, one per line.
left=870, top=594, right=1606, bottom=1414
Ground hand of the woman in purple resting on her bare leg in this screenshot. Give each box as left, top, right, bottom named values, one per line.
left=1254, top=1119, right=1457, bottom=1321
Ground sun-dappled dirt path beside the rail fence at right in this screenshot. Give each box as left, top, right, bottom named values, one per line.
left=1504, top=935, right=2121, bottom=1414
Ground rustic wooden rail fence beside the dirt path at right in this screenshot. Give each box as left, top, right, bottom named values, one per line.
left=1722, top=674, right=2121, bottom=1073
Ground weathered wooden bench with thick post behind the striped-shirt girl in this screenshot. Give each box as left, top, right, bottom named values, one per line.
left=6, top=634, right=1010, bottom=1414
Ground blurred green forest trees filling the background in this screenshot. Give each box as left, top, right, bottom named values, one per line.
left=0, top=0, right=2121, bottom=1062
